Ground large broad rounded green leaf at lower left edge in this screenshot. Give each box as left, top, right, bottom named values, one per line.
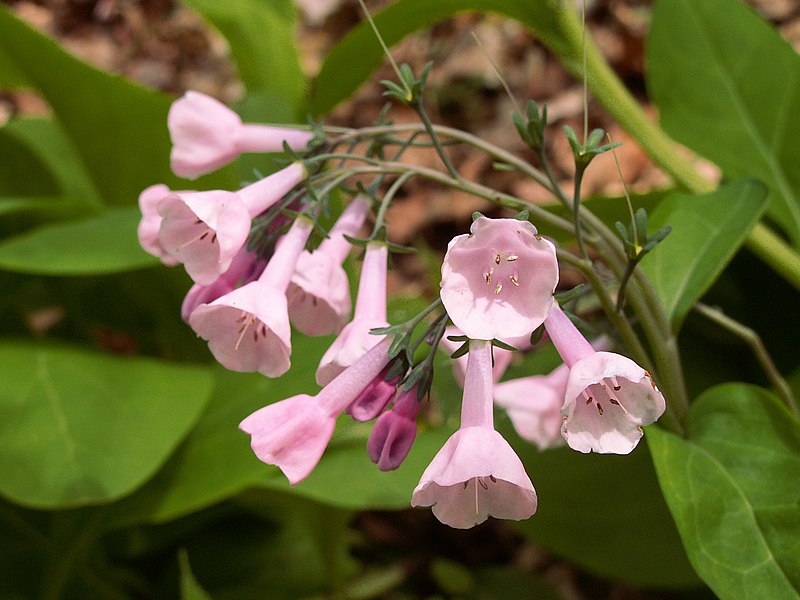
left=0, top=342, right=211, bottom=508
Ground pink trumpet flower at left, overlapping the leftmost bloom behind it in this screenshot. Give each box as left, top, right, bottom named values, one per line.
left=158, top=163, right=306, bottom=285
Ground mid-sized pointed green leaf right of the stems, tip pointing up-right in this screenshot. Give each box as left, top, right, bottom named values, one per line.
left=641, top=181, right=767, bottom=331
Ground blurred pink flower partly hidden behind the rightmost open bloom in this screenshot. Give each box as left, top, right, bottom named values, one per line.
left=494, top=365, right=569, bottom=450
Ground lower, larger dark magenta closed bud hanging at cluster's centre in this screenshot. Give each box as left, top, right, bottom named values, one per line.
left=367, top=387, right=420, bottom=471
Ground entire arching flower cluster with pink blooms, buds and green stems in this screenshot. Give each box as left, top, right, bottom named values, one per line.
left=139, top=79, right=668, bottom=528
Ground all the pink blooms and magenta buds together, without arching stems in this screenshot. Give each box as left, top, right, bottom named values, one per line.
left=139, top=93, right=665, bottom=528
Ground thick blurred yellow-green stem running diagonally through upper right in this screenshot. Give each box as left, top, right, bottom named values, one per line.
left=551, top=3, right=800, bottom=290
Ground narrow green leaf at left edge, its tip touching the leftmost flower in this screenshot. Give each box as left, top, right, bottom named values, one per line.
left=0, top=208, right=159, bottom=275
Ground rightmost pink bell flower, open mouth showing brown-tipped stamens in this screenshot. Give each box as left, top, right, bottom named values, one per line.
left=545, top=305, right=666, bottom=454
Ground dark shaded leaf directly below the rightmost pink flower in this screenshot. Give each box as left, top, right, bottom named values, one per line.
left=512, top=434, right=699, bottom=588
